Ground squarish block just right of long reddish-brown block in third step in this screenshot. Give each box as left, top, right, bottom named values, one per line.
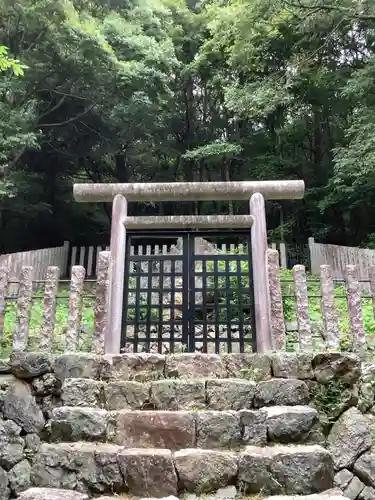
left=196, top=411, right=241, bottom=449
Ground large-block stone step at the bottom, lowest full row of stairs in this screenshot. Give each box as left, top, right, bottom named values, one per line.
left=30, top=442, right=333, bottom=500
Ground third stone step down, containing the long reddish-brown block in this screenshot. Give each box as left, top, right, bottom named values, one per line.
left=46, top=406, right=323, bottom=450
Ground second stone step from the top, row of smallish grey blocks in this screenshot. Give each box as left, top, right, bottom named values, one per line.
left=61, top=378, right=309, bottom=411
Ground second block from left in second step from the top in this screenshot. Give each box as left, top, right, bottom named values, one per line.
left=104, top=380, right=150, bottom=410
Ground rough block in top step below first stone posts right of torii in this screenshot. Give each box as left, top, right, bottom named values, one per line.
left=271, top=352, right=314, bottom=379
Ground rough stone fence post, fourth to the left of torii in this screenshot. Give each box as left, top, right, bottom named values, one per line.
left=13, top=266, right=34, bottom=351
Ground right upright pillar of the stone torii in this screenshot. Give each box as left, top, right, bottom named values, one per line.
left=250, top=193, right=272, bottom=352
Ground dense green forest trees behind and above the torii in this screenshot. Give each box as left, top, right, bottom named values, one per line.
left=0, top=0, right=375, bottom=252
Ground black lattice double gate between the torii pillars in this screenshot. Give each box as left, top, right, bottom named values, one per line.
left=122, top=231, right=256, bottom=353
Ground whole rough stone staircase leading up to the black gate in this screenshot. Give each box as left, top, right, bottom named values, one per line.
left=20, top=354, right=341, bottom=500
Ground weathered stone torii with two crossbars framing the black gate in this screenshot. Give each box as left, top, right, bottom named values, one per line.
left=73, top=180, right=305, bottom=354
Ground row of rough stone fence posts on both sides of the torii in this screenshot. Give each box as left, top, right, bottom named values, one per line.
left=0, top=249, right=375, bottom=357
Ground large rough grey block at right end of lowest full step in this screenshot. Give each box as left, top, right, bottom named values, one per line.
left=238, top=445, right=333, bottom=495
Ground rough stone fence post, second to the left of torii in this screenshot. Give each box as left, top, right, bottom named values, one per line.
left=66, top=266, right=85, bottom=352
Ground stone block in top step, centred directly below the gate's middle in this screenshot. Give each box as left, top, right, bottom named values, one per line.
left=165, top=353, right=227, bottom=378
